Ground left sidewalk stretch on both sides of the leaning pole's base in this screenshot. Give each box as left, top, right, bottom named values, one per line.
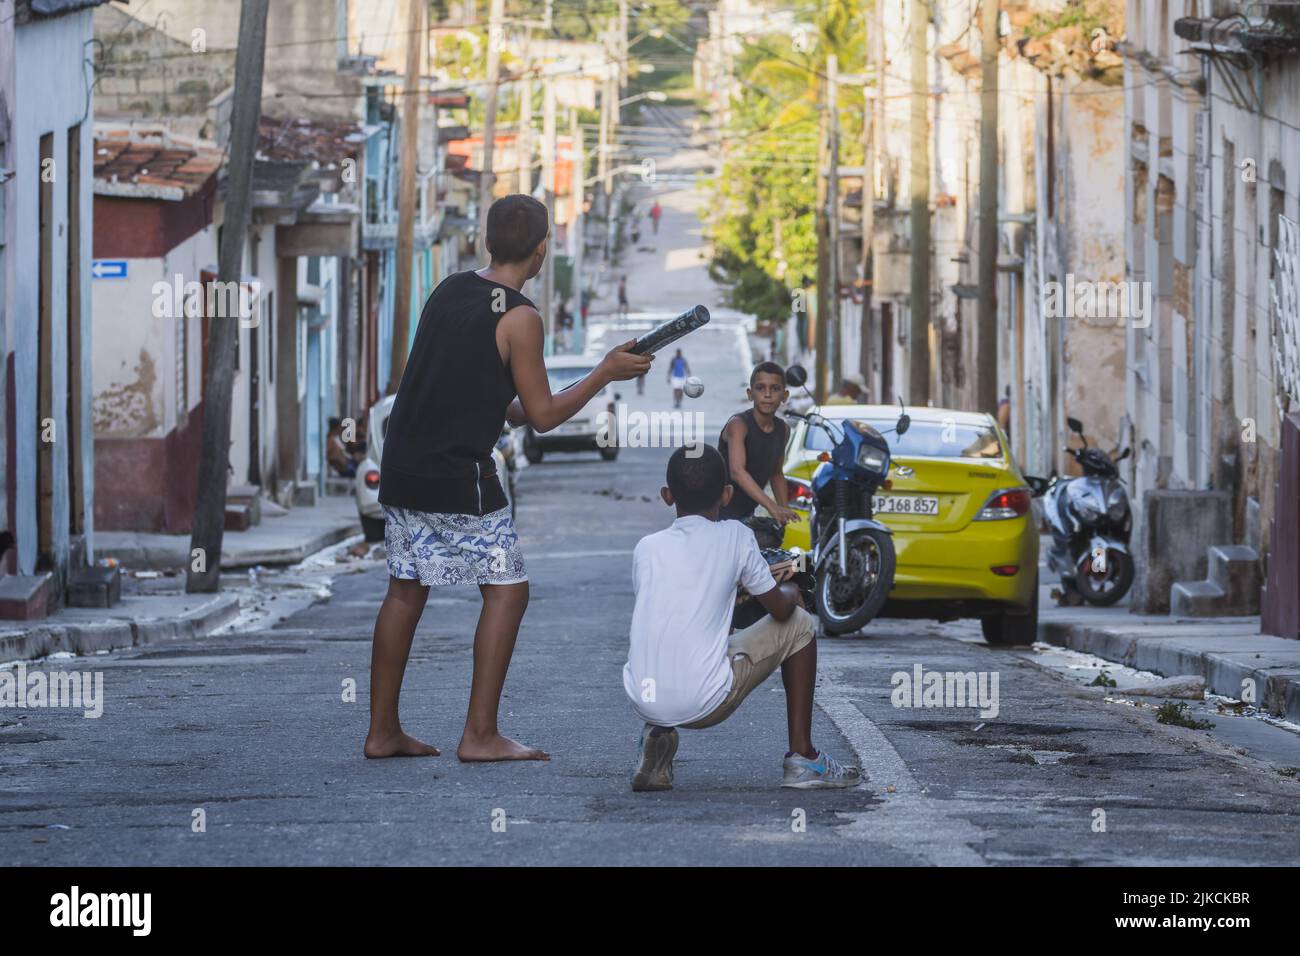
left=95, top=494, right=361, bottom=571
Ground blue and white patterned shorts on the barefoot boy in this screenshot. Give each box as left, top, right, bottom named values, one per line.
left=384, top=505, right=528, bottom=585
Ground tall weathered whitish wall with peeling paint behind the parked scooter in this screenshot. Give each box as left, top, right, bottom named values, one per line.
left=1125, top=0, right=1300, bottom=554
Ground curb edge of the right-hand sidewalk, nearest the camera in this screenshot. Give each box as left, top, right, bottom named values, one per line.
left=1039, top=620, right=1300, bottom=723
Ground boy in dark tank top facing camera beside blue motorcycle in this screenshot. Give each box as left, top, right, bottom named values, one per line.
left=718, top=362, right=797, bottom=527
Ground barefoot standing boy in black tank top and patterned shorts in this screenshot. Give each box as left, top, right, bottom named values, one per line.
left=364, top=195, right=651, bottom=761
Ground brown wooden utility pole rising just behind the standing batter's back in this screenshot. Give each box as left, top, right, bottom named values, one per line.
left=385, top=0, right=425, bottom=395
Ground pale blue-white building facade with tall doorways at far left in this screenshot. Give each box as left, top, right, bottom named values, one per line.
left=0, top=0, right=109, bottom=617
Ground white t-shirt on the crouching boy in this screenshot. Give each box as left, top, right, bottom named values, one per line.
left=623, top=515, right=776, bottom=727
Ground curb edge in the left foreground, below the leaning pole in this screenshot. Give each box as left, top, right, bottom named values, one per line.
left=0, top=594, right=239, bottom=661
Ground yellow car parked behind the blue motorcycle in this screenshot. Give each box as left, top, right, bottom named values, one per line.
left=783, top=405, right=1039, bottom=645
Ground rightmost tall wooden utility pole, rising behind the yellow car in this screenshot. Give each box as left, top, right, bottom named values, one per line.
left=975, top=0, right=998, bottom=412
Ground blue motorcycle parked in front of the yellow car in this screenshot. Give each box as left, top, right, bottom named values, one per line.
left=785, top=365, right=911, bottom=635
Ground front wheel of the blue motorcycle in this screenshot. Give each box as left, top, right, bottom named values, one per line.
left=813, top=528, right=894, bottom=635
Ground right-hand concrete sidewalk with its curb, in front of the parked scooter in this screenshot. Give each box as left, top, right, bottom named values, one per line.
left=1039, top=607, right=1300, bottom=723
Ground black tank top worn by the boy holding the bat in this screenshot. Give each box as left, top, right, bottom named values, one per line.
left=380, top=271, right=533, bottom=515
